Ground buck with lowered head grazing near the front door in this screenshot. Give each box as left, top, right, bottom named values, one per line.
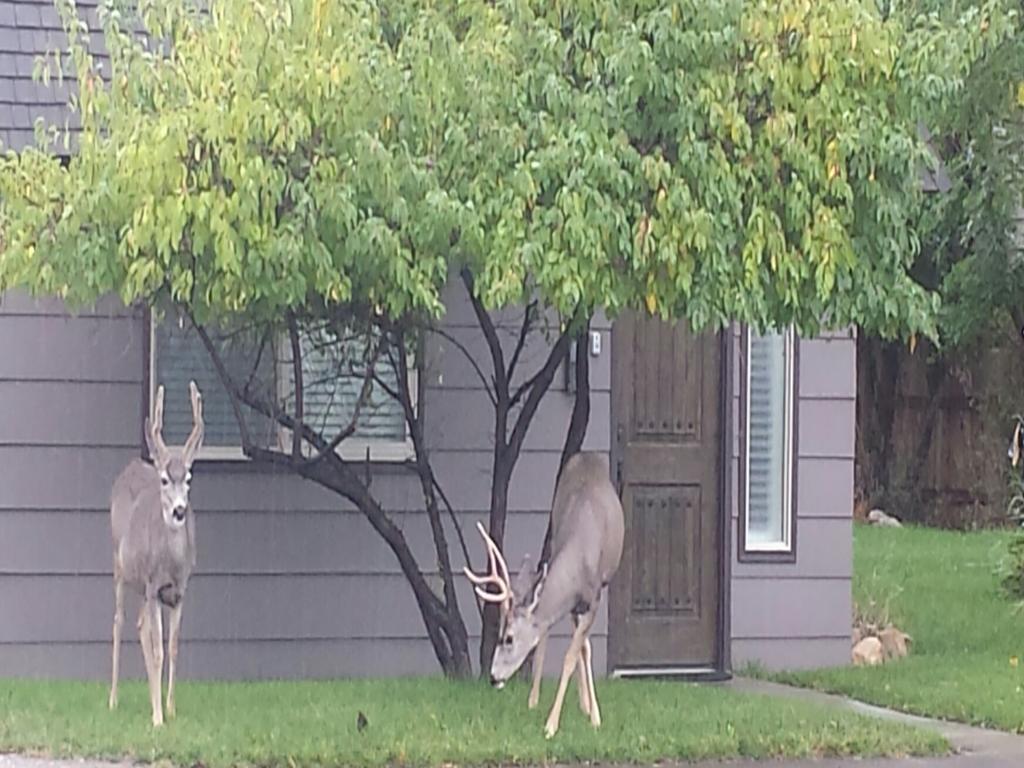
left=465, top=453, right=624, bottom=738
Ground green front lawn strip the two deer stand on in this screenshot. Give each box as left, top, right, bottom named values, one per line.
left=0, top=680, right=946, bottom=768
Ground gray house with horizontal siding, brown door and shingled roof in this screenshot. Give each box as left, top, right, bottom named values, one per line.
left=0, top=0, right=856, bottom=679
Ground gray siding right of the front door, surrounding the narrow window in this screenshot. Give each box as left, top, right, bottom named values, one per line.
left=728, top=331, right=856, bottom=668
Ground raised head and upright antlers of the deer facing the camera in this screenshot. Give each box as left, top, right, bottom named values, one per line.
left=145, top=381, right=204, bottom=529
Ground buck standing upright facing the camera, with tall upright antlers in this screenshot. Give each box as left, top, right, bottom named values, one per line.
left=110, top=382, right=203, bottom=726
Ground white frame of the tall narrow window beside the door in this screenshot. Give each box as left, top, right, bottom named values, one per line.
left=739, top=327, right=799, bottom=555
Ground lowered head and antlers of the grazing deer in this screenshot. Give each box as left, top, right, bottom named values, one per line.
left=463, top=522, right=548, bottom=688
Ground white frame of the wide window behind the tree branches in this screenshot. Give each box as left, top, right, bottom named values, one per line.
left=146, top=312, right=420, bottom=464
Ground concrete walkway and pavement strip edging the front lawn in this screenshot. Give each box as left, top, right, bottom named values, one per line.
left=0, top=678, right=1024, bottom=768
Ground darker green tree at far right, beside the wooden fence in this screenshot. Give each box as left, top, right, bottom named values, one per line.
left=857, top=0, right=1024, bottom=516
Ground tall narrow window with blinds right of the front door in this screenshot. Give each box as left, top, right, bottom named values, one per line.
left=743, top=330, right=795, bottom=553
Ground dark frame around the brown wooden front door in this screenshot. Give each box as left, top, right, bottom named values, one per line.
left=607, top=324, right=737, bottom=681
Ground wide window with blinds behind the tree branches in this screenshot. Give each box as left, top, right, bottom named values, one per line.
left=152, top=316, right=407, bottom=459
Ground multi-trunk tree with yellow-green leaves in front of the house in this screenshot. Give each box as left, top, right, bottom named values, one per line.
left=0, top=0, right=1008, bottom=675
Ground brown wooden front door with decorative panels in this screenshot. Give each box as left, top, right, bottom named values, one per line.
left=608, top=313, right=725, bottom=671
